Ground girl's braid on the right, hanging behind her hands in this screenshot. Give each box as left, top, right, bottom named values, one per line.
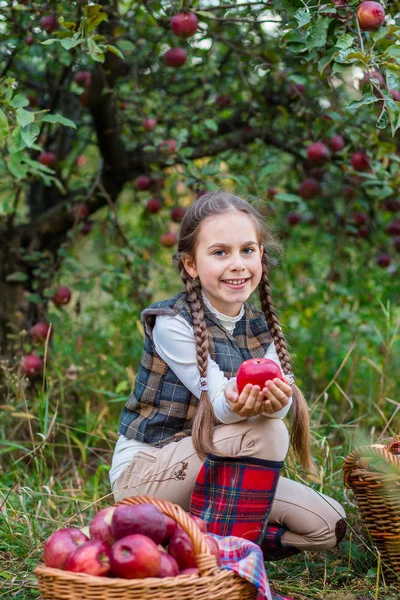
left=259, top=252, right=315, bottom=472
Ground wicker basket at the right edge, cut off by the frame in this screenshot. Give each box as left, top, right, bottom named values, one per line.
left=343, top=443, right=400, bottom=586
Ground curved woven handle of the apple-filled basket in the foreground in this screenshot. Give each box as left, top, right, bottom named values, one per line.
left=115, top=496, right=219, bottom=577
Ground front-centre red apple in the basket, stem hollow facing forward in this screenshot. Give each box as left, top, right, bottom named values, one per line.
left=110, top=536, right=161, bottom=579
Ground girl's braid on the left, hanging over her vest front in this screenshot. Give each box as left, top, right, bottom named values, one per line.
left=178, top=260, right=222, bottom=459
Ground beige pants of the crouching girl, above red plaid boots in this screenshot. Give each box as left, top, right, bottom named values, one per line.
left=113, top=416, right=345, bottom=551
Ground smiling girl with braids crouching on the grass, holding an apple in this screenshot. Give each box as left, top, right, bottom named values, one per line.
left=110, top=192, right=345, bottom=560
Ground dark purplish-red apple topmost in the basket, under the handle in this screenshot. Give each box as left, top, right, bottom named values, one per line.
left=111, top=504, right=165, bottom=545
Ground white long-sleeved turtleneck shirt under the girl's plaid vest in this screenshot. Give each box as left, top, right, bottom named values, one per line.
left=110, top=293, right=292, bottom=485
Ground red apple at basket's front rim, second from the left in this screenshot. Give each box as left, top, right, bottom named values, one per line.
left=65, top=540, right=111, bottom=576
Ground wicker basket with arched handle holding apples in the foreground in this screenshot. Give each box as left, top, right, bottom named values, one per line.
left=34, top=496, right=257, bottom=600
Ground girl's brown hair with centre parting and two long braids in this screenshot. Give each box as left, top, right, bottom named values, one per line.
left=174, top=192, right=314, bottom=471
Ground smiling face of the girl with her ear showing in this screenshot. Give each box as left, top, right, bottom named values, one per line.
left=182, top=211, right=263, bottom=317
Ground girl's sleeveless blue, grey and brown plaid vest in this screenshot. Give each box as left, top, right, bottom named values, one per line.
left=118, top=292, right=273, bottom=447
